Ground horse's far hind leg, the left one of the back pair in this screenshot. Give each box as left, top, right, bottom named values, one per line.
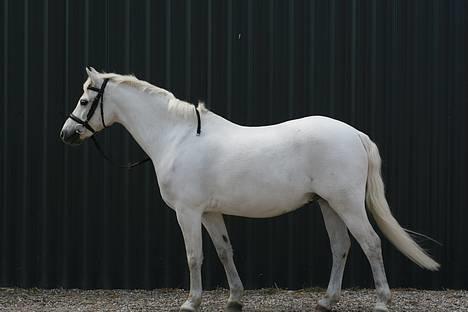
left=317, top=200, right=351, bottom=311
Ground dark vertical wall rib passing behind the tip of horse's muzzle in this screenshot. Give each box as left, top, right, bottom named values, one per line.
left=62, top=0, right=70, bottom=287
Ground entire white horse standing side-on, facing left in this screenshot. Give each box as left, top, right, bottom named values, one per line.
left=61, top=68, right=439, bottom=311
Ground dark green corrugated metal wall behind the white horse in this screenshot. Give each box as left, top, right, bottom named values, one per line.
left=0, top=0, right=468, bottom=288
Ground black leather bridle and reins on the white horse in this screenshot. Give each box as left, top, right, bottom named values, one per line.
left=69, top=78, right=201, bottom=169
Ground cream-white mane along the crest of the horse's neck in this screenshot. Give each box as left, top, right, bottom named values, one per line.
left=83, top=73, right=207, bottom=118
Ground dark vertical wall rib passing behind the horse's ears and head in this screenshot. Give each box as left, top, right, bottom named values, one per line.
left=81, top=0, right=90, bottom=288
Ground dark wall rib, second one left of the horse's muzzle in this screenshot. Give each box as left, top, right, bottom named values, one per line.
left=20, top=0, right=29, bottom=287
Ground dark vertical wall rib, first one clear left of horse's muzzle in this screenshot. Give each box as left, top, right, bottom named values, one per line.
left=40, top=0, right=48, bottom=287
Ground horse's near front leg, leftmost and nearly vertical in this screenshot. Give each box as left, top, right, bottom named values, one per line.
left=176, top=209, right=203, bottom=311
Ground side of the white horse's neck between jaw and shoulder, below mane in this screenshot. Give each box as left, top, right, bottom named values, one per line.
left=112, top=87, right=189, bottom=162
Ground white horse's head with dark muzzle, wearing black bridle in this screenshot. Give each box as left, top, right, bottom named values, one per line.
left=60, top=67, right=112, bottom=145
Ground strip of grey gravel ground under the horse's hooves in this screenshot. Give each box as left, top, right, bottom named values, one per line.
left=0, top=288, right=468, bottom=312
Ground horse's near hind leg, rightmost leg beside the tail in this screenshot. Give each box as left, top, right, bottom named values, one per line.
left=328, top=192, right=391, bottom=312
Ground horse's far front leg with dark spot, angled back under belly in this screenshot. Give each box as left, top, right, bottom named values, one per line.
left=202, top=213, right=244, bottom=311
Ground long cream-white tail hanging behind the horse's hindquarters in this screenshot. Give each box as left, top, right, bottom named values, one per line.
left=359, top=132, right=440, bottom=271
